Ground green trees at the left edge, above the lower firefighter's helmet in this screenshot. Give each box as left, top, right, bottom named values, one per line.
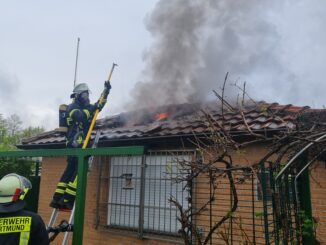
left=0, top=114, right=44, bottom=178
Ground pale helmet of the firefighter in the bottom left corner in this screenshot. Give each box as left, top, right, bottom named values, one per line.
left=0, top=173, right=32, bottom=213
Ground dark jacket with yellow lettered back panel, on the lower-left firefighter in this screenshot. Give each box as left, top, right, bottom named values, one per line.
left=0, top=210, right=49, bottom=245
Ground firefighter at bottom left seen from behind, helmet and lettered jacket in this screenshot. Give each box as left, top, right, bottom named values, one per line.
left=0, top=173, right=49, bottom=245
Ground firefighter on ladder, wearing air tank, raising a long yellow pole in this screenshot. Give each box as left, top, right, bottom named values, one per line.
left=50, top=81, right=111, bottom=209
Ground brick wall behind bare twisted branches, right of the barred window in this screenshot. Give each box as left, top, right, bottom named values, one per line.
left=193, top=146, right=272, bottom=245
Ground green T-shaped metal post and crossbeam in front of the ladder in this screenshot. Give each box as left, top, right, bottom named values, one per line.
left=0, top=146, right=144, bottom=245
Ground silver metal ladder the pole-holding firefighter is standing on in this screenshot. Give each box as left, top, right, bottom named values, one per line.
left=47, top=130, right=101, bottom=245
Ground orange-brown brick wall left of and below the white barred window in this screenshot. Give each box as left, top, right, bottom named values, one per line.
left=39, top=158, right=180, bottom=245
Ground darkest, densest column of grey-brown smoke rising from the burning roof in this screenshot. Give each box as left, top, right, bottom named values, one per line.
left=126, top=0, right=207, bottom=108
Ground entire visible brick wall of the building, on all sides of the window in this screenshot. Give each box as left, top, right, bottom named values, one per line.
left=39, top=145, right=326, bottom=245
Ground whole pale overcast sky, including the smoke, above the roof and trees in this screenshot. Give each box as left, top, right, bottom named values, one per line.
left=0, top=0, right=326, bottom=130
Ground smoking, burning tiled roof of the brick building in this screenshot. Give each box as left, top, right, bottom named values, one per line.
left=18, top=102, right=314, bottom=148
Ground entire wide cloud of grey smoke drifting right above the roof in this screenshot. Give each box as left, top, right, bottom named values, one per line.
left=130, top=0, right=306, bottom=109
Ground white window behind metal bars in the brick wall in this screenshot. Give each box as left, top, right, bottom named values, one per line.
left=107, top=152, right=192, bottom=234
